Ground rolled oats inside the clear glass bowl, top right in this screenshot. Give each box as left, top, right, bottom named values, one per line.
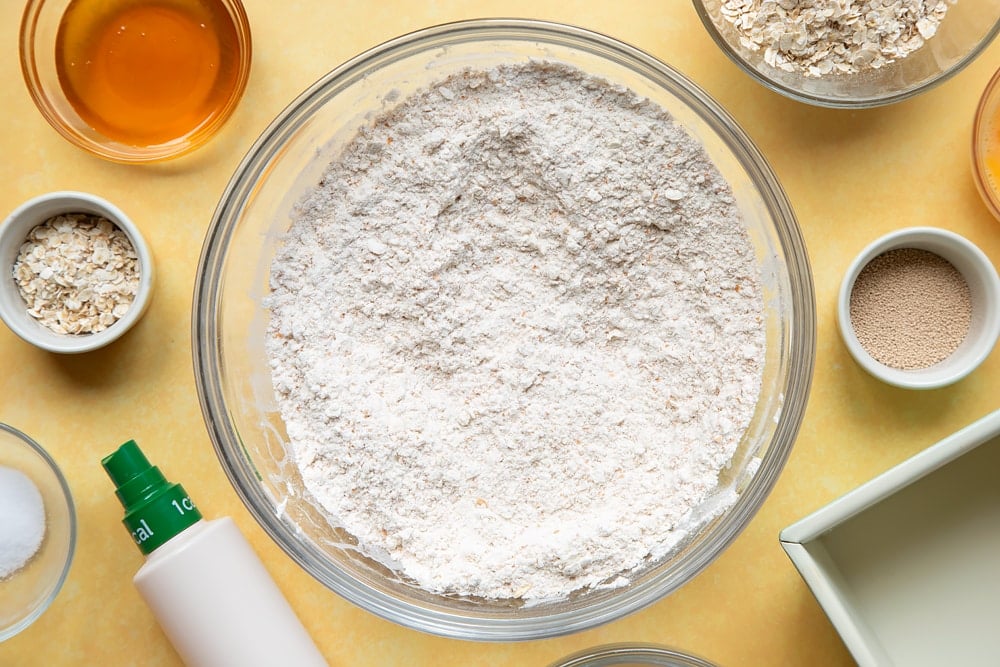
left=720, top=0, right=957, bottom=77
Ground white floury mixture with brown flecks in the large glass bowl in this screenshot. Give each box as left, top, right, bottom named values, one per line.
left=267, top=62, right=765, bottom=601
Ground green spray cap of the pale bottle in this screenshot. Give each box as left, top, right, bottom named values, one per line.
left=101, top=440, right=201, bottom=554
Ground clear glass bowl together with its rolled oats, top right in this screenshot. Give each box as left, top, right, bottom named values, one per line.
left=694, top=0, right=1000, bottom=108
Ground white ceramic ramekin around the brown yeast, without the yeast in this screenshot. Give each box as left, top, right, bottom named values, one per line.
left=837, top=227, right=1000, bottom=389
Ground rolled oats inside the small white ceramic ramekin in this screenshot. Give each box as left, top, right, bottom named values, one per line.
left=13, top=213, right=139, bottom=334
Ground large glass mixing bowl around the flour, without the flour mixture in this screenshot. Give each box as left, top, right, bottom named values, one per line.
left=193, top=19, right=815, bottom=641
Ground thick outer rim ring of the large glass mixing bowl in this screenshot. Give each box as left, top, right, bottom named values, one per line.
left=191, top=18, right=815, bottom=641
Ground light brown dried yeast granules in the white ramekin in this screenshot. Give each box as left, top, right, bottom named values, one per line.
left=850, top=248, right=972, bottom=370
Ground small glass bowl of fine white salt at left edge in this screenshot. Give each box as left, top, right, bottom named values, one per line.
left=0, top=423, right=76, bottom=642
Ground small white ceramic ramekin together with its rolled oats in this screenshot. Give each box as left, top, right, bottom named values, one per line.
left=0, top=191, right=154, bottom=354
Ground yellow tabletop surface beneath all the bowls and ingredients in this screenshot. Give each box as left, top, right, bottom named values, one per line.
left=0, top=0, right=1000, bottom=667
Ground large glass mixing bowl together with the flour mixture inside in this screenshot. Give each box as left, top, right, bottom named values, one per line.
left=192, top=19, right=815, bottom=641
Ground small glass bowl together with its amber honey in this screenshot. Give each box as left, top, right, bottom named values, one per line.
left=20, top=0, right=251, bottom=162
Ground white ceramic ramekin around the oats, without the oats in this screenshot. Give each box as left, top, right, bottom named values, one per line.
left=0, top=191, right=154, bottom=354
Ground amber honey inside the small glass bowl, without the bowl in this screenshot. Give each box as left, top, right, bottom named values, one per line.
left=56, top=0, right=246, bottom=146
